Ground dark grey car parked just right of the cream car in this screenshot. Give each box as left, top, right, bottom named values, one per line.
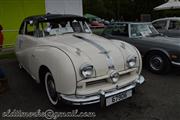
left=102, top=22, right=180, bottom=74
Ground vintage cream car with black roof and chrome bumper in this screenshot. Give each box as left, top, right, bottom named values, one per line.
left=16, top=14, right=144, bottom=106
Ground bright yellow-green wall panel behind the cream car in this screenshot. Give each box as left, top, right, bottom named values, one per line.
left=0, top=0, right=45, bottom=45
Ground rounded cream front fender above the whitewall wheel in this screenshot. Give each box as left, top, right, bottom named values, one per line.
left=34, top=46, right=77, bottom=94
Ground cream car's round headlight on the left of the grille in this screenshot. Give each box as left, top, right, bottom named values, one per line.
left=80, top=65, right=94, bottom=79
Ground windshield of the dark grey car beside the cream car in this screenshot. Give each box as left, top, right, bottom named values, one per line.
left=131, top=24, right=160, bottom=37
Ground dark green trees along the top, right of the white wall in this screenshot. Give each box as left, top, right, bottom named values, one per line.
left=83, top=0, right=165, bottom=21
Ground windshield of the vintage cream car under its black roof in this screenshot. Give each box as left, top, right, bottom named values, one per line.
left=38, top=20, right=91, bottom=37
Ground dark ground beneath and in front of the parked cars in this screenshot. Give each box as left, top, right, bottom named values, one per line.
left=0, top=60, right=180, bottom=120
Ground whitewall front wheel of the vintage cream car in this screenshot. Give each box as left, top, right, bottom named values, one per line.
left=45, top=72, right=60, bottom=106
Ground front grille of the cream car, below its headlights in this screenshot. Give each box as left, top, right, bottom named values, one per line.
left=77, top=68, right=138, bottom=94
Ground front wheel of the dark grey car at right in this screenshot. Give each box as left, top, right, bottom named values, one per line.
left=146, top=52, right=171, bottom=74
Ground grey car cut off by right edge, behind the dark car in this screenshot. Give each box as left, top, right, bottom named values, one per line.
left=152, top=17, right=180, bottom=37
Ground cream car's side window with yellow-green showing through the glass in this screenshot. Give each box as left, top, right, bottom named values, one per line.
left=25, top=21, right=35, bottom=36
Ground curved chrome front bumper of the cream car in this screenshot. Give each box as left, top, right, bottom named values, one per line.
left=59, top=76, right=144, bottom=105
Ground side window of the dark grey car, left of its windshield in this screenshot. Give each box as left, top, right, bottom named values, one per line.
left=112, top=24, right=128, bottom=37
